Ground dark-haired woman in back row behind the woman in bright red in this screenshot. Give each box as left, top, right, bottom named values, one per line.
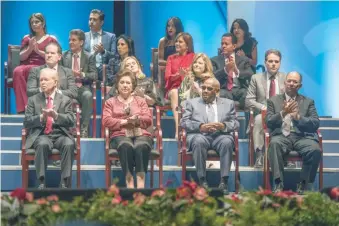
left=158, top=17, right=184, bottom=66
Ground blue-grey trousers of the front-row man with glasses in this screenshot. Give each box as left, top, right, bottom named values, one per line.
left=189, top=134, right=234, bottom=179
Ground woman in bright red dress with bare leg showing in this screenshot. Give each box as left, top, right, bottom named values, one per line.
left=165, top=32, right=194, bottom=139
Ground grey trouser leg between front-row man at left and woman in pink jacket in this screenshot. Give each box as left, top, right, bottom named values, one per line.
left=77, top=86, right=93, bottom=128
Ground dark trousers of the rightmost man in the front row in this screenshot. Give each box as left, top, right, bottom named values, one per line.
left=268, top=133, right=321, bottom=183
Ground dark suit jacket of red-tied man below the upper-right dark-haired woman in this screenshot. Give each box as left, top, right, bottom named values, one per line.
left=211, top=54, right=253, bottom=88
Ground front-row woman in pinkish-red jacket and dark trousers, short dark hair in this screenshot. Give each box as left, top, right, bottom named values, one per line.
left=102, top=70, right=153, bottom=188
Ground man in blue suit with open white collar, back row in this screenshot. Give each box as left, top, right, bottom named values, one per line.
left=84, top=9, right=116, bottom=80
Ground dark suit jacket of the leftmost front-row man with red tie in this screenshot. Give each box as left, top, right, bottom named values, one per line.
left=24, top=93, right=75, bottom=148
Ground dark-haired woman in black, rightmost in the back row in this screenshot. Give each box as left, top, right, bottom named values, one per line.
left=231, top=19, right=258, bottom=73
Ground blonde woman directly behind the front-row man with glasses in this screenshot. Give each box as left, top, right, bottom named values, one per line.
left=179, top=53, right=214, bottom=103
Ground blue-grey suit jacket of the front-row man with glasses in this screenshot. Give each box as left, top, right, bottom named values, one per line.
left=180, top=97, right=239, bottom=143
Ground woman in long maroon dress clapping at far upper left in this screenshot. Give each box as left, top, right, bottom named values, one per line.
left=13, top=13, right=57, bottom=113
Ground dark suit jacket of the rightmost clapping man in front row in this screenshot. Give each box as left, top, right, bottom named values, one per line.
left=266, top=93, right=320, bottom=140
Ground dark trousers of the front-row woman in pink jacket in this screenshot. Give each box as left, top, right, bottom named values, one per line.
left=110, top=136, right=153, bottom=175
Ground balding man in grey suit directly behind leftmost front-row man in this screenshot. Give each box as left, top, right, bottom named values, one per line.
left=27, top=42, right=78, bottom=99
